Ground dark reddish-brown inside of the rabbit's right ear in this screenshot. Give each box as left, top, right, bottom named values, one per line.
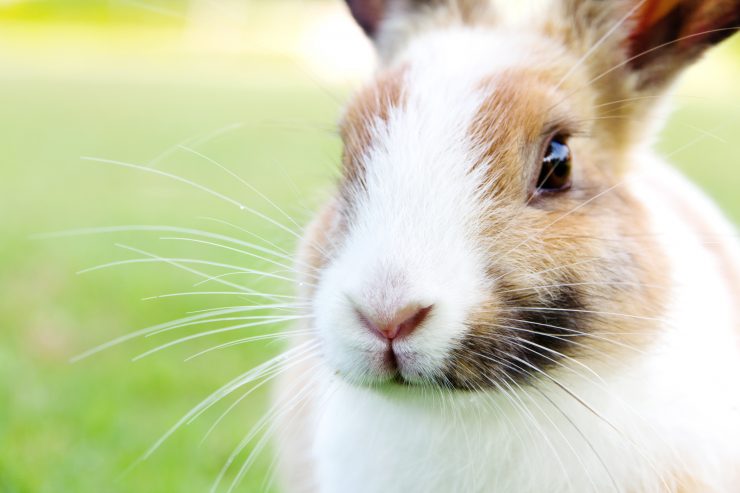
left=628, top=0, right=740, bottom=86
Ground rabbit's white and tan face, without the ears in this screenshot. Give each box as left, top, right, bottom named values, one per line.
left=314, top=29, right=664, bottom=390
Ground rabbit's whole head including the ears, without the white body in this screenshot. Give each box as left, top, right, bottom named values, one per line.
left=304, top=0, right=740, bottom=389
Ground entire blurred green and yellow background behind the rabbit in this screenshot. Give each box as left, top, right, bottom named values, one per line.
left=0, top=0, right=740, bottom=493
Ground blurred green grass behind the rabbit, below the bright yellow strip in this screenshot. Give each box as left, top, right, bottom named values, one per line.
left=0, top=15, right=740, bottom=493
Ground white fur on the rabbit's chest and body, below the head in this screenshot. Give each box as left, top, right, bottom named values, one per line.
left=304, top=159, right=740, bottom=493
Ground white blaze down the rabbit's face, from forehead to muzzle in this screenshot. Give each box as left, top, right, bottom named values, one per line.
left=315, top=30, right=548, bottom=380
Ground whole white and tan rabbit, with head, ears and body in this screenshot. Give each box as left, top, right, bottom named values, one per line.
left=274, top=0, right=740, bottom=493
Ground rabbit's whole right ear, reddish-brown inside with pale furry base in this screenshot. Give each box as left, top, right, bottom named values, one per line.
left=545, top=0, right=740, bottom=152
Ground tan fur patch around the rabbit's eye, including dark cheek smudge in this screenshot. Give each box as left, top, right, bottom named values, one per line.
left=441, top=66, right=667, bottom=389
